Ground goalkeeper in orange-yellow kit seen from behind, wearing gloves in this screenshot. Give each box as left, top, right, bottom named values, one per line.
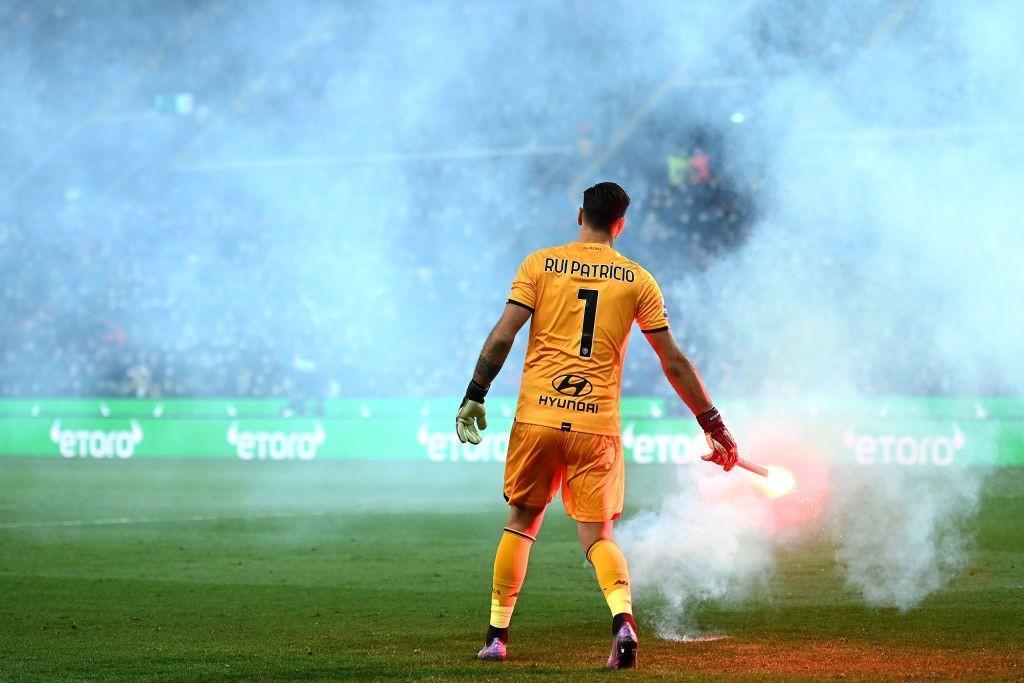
left=456, top=182, right=737, bottom=669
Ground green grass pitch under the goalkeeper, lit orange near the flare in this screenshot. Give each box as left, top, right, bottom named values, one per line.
left=0, top=459, right=1024, bottom=680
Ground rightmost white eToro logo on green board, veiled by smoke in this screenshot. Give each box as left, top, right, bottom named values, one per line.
left=843, top=424, right=967, bottom=467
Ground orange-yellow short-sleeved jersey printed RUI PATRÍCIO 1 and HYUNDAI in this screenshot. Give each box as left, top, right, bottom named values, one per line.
left=509, top=242, right=669, bottom=435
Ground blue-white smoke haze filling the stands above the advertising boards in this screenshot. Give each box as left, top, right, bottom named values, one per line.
left=0, top=0, right=1024, bottom=395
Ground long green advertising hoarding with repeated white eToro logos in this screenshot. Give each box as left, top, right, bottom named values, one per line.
left=0, top=398, right=1024, bottom=467
